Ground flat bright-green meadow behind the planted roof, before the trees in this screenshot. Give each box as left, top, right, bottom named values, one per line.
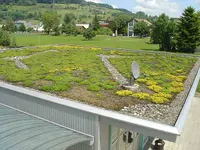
left=14, top=34, right=158, bottom=50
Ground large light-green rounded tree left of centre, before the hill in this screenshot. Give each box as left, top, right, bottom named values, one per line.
left=42, top=12, right=60, bottom=34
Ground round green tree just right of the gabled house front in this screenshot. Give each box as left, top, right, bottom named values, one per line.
left=134, top=21, right=149, bottom=38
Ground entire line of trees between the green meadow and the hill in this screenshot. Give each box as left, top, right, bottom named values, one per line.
left=0, top=7, right=200, bottom=53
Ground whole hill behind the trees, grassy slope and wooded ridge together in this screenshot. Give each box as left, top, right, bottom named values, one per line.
left=0, top=0, right=157, bottom=24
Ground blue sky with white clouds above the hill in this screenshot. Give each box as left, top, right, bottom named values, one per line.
left=86, top=0, right=200, bottom=17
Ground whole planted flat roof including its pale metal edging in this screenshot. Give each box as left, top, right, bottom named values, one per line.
left=0, top=45, right=200, bottom=141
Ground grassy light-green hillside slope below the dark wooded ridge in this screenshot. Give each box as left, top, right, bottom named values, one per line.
left=0, top=3, right=132, bottom=24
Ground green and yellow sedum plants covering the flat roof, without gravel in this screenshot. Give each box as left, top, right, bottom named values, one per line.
left=0, top=45, right=196, bottom=110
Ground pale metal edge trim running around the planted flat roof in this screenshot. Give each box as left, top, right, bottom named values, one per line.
left=0, top=65, right=200, bottom=142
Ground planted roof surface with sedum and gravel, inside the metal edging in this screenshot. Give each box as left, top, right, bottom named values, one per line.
left=0, top=45, right=200, bottom=125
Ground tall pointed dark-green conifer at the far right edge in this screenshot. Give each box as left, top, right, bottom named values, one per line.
left=177, top=7, right=200, bottom=53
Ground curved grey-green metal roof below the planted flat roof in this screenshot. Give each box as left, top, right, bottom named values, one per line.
left=0, top=105, right=93, bottom=150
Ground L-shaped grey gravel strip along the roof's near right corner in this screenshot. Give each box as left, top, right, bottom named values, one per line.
left=121, top=58, right=200, bottom=125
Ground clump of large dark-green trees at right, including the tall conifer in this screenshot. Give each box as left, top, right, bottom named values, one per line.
left=151, top=7, right=200, bottom=53
